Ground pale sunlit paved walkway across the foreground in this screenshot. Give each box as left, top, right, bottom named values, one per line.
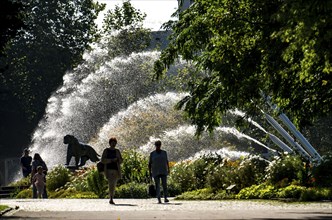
left=0, top=198, right=332, bottom=220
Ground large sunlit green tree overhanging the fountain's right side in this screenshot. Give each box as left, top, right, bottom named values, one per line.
left=155, top=0, right=332, bottom=132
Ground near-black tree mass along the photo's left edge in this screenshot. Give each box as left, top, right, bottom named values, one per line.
left=0, top=0, right=29, bottom=158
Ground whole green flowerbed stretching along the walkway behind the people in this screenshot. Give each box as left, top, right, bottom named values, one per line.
left=11, top=150, right=332, bottom=201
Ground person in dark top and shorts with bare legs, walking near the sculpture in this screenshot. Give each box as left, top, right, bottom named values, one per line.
left=101, top=138, right=122, bottom=204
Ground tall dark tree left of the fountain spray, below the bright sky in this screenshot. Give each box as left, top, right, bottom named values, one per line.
left=3, top=0, right=105, bottom=121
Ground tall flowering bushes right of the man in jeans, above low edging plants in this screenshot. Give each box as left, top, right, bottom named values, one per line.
left=170, top=155, right=268, bottom=192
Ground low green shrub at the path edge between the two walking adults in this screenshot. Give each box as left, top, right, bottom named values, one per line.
left=115, top=182, right=149, bottom=199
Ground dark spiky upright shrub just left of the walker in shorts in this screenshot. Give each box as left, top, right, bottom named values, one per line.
left=87, top=170, right=108, bottom=198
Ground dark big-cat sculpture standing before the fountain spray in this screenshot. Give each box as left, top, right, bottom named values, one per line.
left=63, top=135, right=100, bottom=167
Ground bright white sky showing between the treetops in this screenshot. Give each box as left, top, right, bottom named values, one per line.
left=97, top=0, right=178, bottom=31
